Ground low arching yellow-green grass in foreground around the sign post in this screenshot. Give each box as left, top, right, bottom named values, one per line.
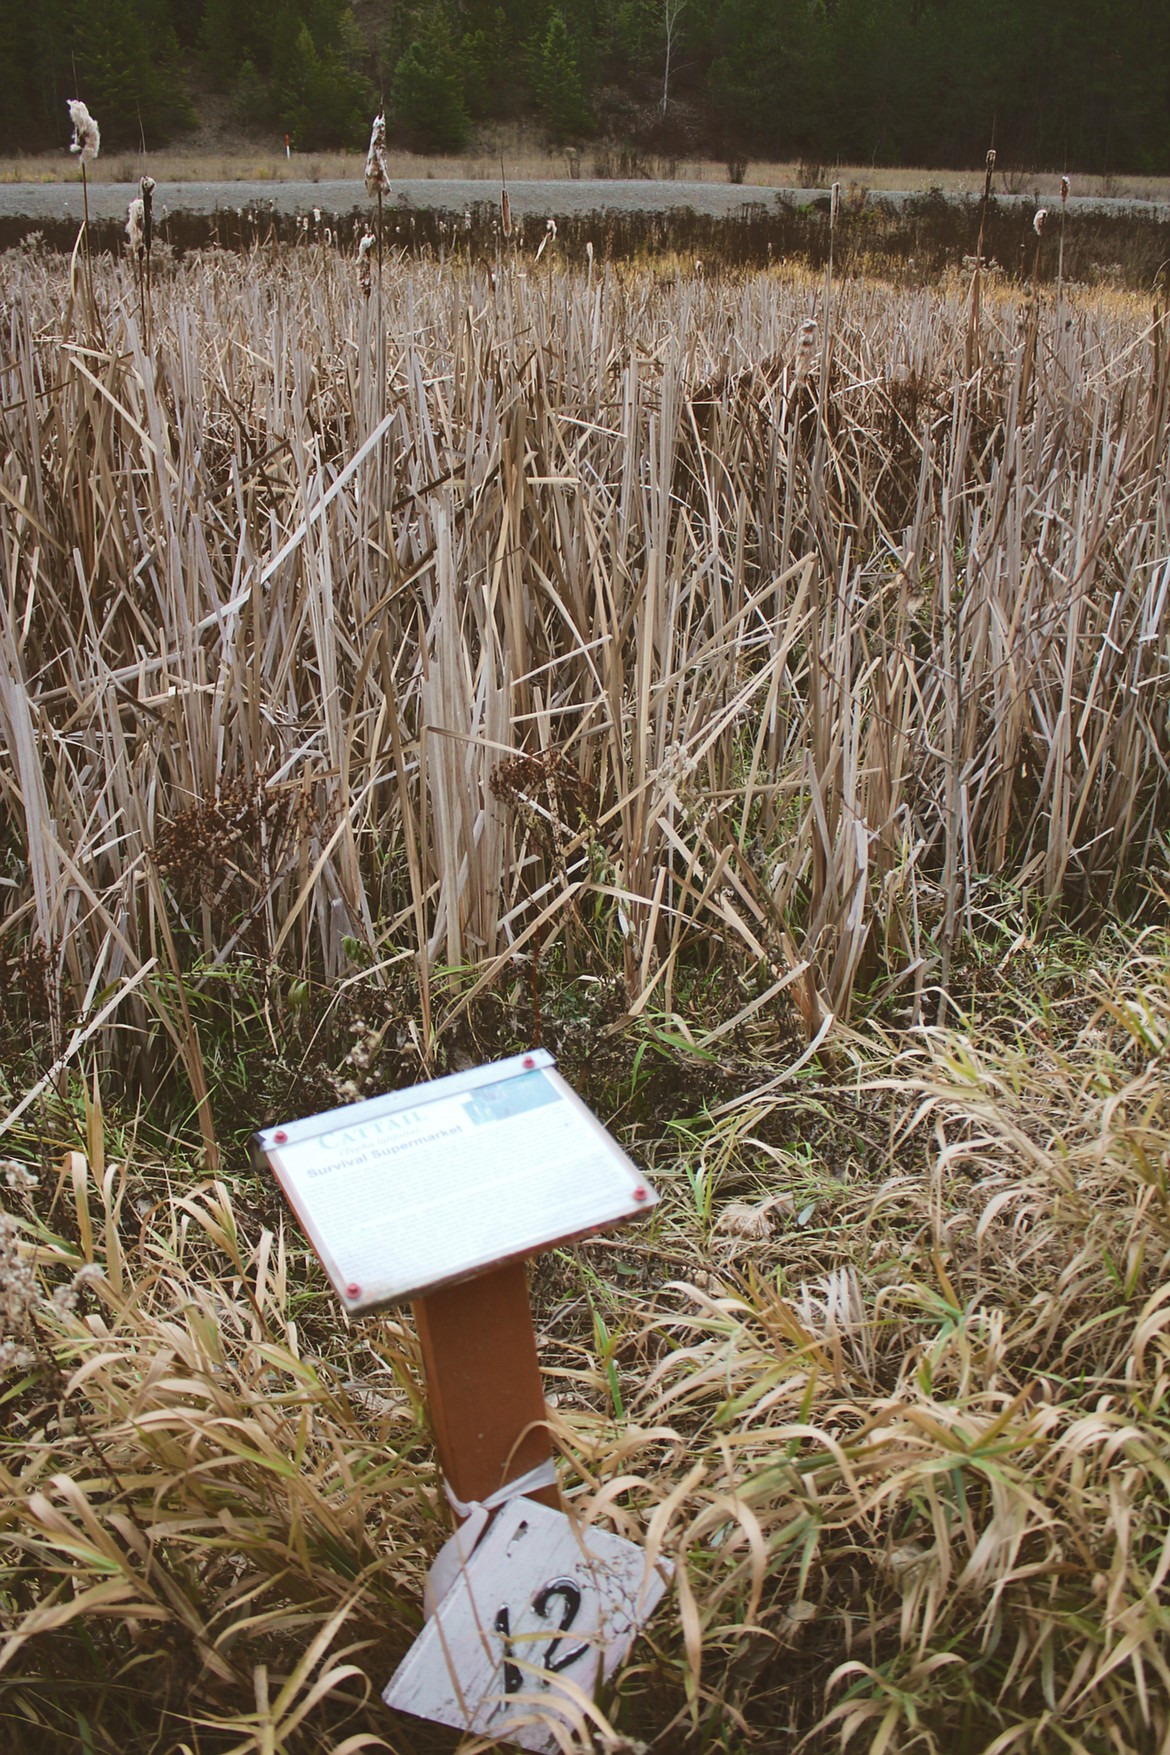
left=0, top=942, right=1170, bottom=1755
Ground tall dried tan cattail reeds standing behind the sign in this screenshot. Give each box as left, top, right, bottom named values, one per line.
left=0, top=253, right=1170, bottom=1095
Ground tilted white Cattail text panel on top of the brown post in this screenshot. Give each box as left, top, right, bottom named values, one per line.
left=256, top=1049, right=658, bottom=1316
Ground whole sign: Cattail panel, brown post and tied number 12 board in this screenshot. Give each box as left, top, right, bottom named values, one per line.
left=254, top=1049, right=670, bottom=1751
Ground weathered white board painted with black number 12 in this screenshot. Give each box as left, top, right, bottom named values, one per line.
left=382, top=1499, right=674, bottom=1751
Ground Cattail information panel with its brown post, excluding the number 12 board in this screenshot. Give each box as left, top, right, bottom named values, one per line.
left=254, top=1049, right=656, bottom=1509
